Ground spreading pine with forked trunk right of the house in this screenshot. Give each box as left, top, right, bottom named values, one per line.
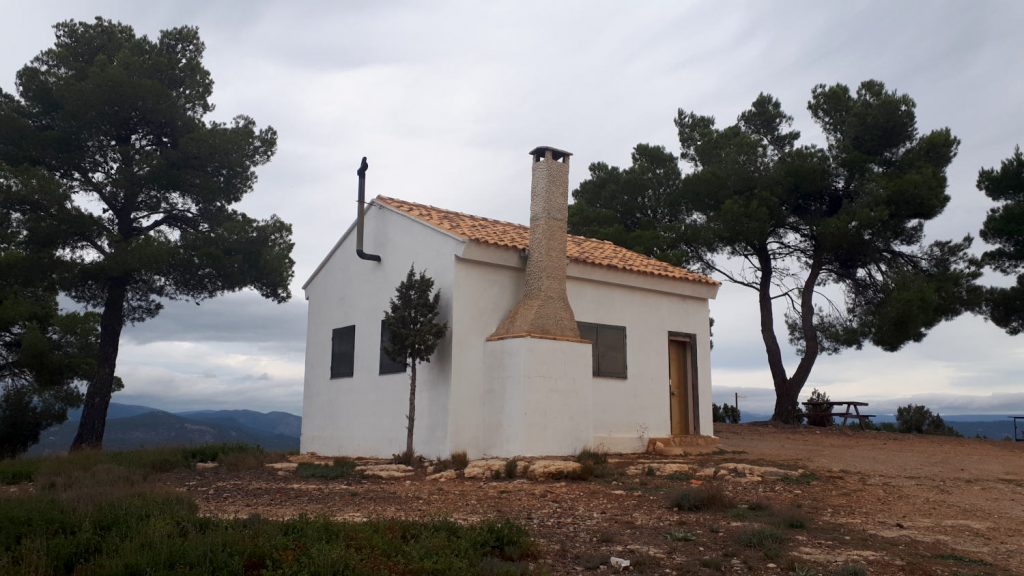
left=569, top=80, right=979, bottom=422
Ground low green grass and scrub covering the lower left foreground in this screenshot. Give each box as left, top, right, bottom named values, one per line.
left=0, top=446, right=535, bottom=575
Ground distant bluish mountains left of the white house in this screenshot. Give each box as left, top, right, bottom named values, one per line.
left=29, top=403, right=302, bottom=455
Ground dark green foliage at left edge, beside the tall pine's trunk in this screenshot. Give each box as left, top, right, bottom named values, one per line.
left=0, top=164, right=98, bottom=458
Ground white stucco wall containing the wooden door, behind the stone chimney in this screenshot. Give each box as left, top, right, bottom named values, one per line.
left=449, top=253, right=717, bottom=457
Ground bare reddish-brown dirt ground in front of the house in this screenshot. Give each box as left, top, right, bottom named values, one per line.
left=168, top=425, right=1024, bottom=576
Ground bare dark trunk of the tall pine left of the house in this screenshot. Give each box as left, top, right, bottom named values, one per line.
left=71, top=278, right=128, bottom=452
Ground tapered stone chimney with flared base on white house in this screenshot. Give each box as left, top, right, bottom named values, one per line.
left=490, top=147, right=580, bottom=340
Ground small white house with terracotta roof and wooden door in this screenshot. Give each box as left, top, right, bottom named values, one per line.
left=301, top=148, right=719, bottom=458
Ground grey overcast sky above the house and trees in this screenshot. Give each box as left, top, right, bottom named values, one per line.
left=0, top=0, right=1024, bottom=414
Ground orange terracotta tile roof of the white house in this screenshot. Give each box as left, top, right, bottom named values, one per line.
left=375, top=196, right=720, bottom=285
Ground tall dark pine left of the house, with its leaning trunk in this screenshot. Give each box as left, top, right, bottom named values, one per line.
left=0, top=17, right=293, bottom=447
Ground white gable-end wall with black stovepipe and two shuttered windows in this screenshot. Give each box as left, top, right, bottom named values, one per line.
left=301, top=206, right=463, bottom=457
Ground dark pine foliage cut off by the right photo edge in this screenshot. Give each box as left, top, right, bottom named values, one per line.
left=978, top=147, right=1024, bottom=334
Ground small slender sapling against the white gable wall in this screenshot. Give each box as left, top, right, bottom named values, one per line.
left=384, top=265, right=447, bottom=464
